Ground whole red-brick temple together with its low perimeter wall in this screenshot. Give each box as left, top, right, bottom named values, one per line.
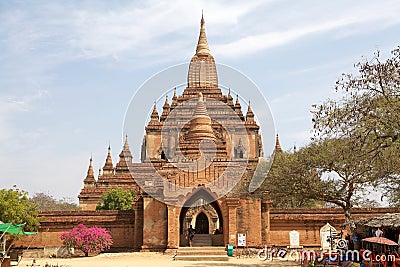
left=15, top=14, right=399, bottom=257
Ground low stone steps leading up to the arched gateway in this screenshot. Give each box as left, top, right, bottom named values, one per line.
left=175, top=247, right=229, bottom=261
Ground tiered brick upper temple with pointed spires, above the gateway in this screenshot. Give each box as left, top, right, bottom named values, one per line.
left=79, top=14, right=262, bottom=209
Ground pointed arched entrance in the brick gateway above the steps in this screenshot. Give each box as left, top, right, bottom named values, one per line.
left=179, top=189, right=224, bottom=246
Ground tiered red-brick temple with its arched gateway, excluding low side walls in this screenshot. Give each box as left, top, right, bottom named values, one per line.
left=79, top=17, right=269, bottom=250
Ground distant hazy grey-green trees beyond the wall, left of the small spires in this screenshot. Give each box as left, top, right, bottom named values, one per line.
left=31, top=193, right=79, bottom=211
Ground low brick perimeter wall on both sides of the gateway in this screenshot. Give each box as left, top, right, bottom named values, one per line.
left=11, top=208, right=400, bottom=251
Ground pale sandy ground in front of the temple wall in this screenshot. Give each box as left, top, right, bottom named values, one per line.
left=18, top=252, right=299, bottom=267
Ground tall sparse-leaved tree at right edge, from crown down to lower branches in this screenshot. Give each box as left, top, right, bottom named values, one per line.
left=313, top=47, right=400, bottom=205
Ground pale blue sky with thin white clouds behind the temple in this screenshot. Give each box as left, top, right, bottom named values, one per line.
left=0, top=0, right=400, bottom=202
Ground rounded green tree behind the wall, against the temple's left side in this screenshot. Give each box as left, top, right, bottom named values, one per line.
left=96, top=187, right=135, bottom=210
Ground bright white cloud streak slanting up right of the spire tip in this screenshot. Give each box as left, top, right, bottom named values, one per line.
left=213, top=1, right=400, bottom=57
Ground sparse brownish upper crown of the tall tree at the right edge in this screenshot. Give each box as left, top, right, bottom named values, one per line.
left=314, top=47, right=400, bottom=148
